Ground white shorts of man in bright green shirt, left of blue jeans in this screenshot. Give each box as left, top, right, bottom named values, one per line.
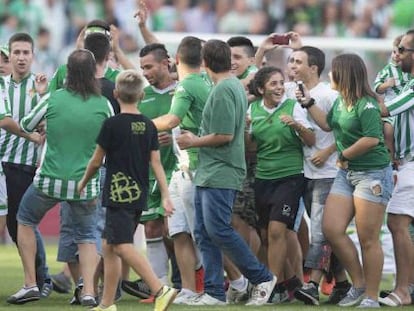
left=168, top=171, right=195, bottom=237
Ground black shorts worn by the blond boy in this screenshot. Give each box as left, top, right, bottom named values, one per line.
left=102, top=207, right=142, bottom=244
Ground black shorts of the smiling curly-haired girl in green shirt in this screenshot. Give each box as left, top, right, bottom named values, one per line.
left=254, top=174, right=305, bottom=230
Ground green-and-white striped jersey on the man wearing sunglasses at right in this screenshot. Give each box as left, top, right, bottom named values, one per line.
left=385, top=79, right=414, bottom=159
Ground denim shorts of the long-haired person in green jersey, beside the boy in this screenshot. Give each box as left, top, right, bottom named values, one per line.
left=17, top=184, right=96, bottom=244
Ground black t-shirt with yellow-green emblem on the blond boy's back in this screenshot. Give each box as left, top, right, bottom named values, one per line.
left=97, top=113, right=159, bottom=210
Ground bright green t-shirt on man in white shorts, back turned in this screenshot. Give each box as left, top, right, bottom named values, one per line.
left=169, top=73, right=211, bottom=170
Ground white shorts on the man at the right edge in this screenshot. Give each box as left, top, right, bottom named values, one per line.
left=387, top=161, right=414, bottom=218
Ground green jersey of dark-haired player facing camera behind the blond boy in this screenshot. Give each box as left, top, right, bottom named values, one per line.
left=138, top=84, right=176, bottom=180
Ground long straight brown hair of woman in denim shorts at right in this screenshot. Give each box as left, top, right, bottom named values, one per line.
left=331, top=54, right=376, bottom=105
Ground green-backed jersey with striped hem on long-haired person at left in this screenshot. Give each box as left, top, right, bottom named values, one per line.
left=20, top=89, right=114, bottom=200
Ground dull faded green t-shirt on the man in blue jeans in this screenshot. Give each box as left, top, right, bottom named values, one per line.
left=194, top=77, right=247, bottom=190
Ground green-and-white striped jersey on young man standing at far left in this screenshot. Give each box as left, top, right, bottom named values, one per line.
left=0, top=73, right=40, bottom=166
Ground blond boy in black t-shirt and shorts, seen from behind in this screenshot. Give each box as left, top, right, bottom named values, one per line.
left=78, top=70, right=177, bottom=311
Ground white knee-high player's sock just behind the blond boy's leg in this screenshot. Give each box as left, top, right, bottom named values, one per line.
left=146, top=237, right=168, bottom=284
